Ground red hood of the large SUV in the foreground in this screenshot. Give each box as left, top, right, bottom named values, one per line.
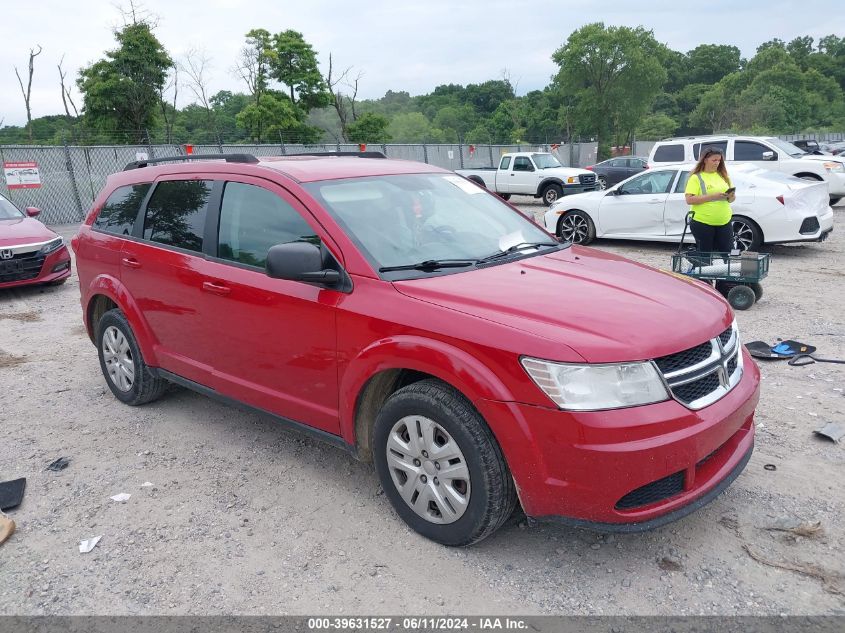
left=394, top=246, right=733, bottom=363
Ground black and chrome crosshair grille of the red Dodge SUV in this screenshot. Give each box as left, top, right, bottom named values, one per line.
left=654, top=325, right=742, bottom=410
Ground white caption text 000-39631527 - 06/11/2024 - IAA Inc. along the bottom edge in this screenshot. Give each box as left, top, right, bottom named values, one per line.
left=308, top=616, right=528, bottom=631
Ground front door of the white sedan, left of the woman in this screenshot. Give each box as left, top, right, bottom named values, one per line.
left=598, top=169, right=677, bottom=239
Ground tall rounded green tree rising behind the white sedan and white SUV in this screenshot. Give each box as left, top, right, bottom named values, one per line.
left=552, top=23, right=666, bottom=160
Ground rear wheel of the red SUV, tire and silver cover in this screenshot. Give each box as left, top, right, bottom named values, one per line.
left=97, top=309, right=168, bottom=406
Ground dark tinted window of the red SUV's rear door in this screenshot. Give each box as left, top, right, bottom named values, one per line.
left=144, top=180, right=214, bottom=252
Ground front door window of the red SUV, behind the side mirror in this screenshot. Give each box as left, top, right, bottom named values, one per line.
left=217, top=182, right=319, bottom=268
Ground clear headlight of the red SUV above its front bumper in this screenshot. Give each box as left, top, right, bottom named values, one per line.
left=521, top=357, right=669, bottom=411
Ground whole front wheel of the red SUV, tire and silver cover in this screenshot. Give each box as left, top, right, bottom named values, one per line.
left=373, top=380, right=516, bottom=546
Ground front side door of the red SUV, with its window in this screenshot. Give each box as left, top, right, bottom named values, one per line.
left=197, top=176, right=345, bottom=434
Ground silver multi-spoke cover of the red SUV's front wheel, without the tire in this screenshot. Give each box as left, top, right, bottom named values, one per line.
left=386, top=415, right=471, bottom=524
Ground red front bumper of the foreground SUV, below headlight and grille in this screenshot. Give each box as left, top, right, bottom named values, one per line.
left=482, top=351, right=760, bottom=531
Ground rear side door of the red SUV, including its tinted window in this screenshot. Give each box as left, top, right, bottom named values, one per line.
left=121, top=178, right=220, bottom=385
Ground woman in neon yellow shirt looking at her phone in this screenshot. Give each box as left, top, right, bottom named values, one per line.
left=684, top=147, right=736, bottom=253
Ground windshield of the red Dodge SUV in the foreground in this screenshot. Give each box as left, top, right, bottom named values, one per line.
left=305, top=174, right=561, bottom=279
